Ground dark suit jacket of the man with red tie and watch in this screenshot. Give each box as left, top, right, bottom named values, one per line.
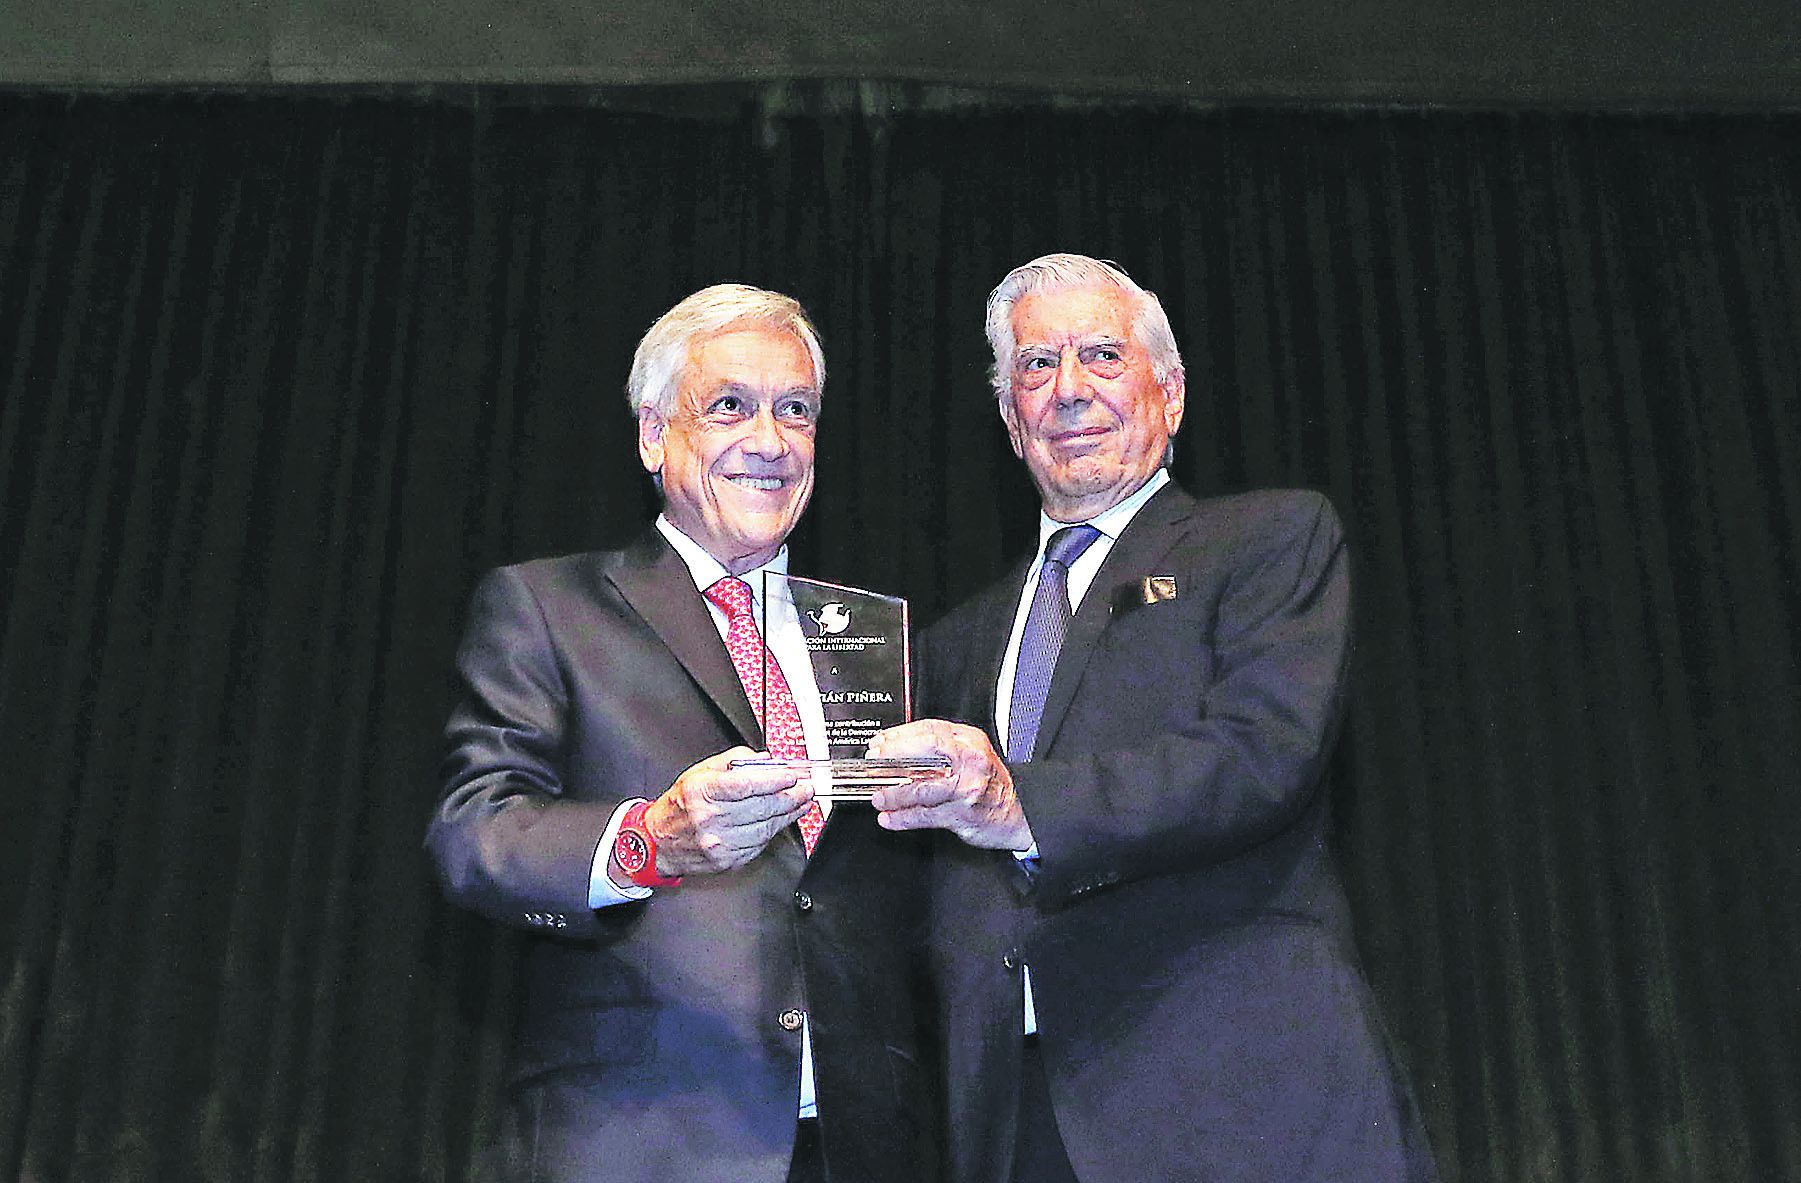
left=427, top=531, right=933, bottom=1183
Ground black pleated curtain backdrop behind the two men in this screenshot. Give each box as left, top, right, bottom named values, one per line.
left=0, top=94, right=1801, bottom=1183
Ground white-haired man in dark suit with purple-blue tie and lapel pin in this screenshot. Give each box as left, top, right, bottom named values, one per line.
left=870, top=256, right=1434, bottom=1183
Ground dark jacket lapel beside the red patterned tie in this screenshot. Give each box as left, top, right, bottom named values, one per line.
left=607, top=529, right=764, bottom=749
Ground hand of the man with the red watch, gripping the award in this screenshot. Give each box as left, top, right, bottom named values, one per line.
left=626, top=747, right=812, bottom=877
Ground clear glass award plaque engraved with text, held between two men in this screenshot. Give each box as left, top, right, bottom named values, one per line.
left=733, top=573, right=951, bottom=801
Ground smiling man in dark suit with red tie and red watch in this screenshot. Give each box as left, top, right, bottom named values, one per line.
left=427, top=284, right=935, bottom=1183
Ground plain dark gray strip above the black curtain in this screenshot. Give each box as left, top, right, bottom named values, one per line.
left=0, top=0, right=1801, bottom=110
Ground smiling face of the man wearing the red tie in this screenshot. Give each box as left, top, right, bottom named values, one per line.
left=638, top=324, right=819, bottom=574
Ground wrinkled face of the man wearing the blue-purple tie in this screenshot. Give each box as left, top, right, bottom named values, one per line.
left=1001, top=284, right=1183, bottom=522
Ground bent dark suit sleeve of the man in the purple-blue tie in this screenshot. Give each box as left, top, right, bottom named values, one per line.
left=1010, top=495, right=1351, bottom=906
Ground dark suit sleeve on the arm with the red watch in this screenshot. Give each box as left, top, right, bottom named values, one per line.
left=425, top=569, right=623, bottom=938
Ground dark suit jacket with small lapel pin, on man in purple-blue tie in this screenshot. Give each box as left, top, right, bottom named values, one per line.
left=920, top=486, right=1432, bottom=1183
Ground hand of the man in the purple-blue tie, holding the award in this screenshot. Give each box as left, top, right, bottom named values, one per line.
left=870, top=718, right=1032, bottom=850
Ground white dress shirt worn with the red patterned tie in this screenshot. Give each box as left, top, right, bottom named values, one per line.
left=587, top=515, right=832, bottom=1118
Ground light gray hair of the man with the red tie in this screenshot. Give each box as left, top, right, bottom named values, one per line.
left=625, top=283, right=825, bottom=420
